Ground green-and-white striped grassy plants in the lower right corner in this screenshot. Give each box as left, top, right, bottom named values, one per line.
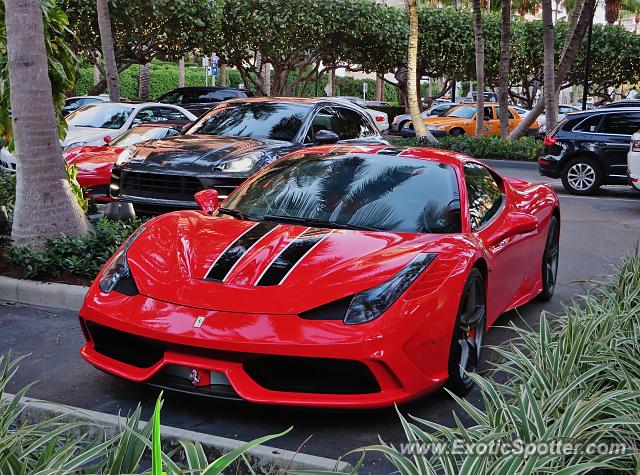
left=318, top=250, right=640, bottom=475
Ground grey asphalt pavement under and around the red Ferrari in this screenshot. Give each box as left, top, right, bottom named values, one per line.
left=0, top=161, right=640, bottom=474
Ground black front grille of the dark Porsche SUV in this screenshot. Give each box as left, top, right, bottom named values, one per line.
left=121, top=172, right=203, bottom=201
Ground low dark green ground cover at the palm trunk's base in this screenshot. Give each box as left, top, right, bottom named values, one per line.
left=4, top=219, right=143, bottom=279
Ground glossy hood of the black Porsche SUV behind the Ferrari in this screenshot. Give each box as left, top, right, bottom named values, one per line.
left=127, top=135, right=298, bottom=176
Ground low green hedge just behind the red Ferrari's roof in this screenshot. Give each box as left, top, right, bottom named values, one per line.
left=392, top=135, right=544, bottom=161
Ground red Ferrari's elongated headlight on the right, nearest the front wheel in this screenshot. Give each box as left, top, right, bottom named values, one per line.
left=344, top=253, right=436, bottom=325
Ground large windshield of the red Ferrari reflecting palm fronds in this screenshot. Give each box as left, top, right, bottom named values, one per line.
left=223, top=154, right=460, bottom=233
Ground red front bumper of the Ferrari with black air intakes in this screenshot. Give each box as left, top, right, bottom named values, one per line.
left=80, top=289, right=451, bottom=408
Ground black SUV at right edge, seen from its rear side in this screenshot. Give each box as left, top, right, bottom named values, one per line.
left=538, top=108, right=640, bottom=195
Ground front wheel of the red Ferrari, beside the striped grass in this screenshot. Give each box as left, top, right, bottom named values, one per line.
left=445, top=267, right=487, bottom=397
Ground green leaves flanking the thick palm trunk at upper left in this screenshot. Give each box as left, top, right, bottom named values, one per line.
left=0, top=0, right=78, bottom=150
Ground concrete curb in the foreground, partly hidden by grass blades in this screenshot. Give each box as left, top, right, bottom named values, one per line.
left=2, top=393, right=351, bottom=473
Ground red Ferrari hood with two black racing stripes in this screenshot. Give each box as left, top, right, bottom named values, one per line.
left=127, top=211, right=464, bottom=314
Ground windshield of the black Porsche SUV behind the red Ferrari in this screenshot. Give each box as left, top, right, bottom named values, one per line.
left=188, top=102, right=312, bottom=142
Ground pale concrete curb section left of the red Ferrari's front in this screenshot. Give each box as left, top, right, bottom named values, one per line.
left=0, top=276, right=89, bottom=311
